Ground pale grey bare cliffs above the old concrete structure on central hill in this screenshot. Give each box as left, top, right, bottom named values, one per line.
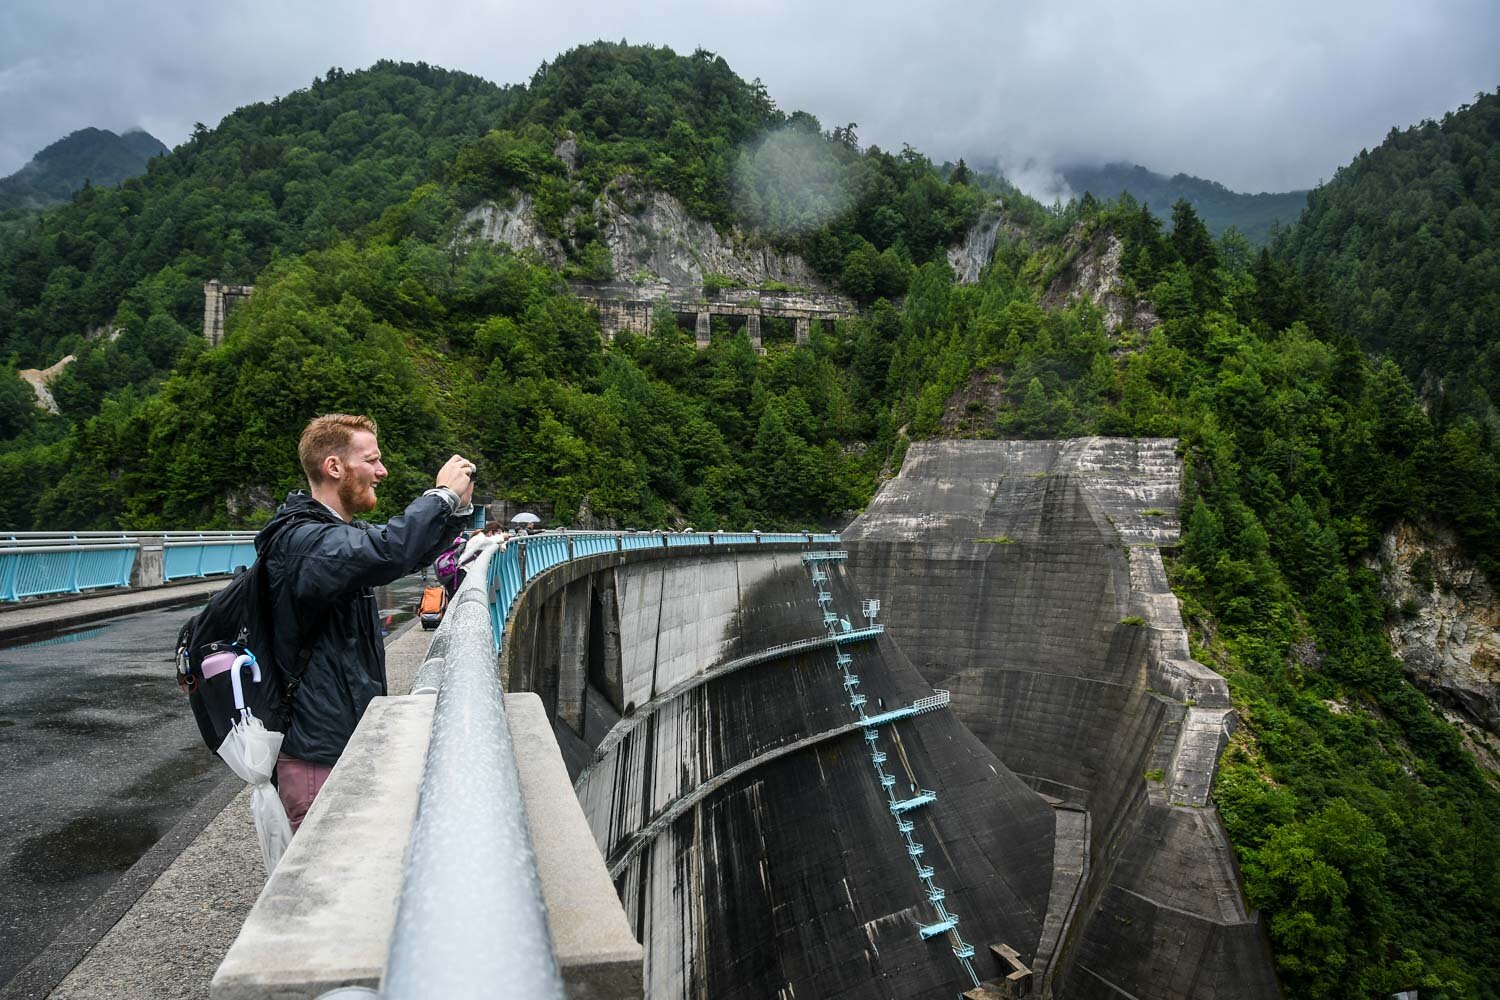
left=465, top=177, right=825, bottom=291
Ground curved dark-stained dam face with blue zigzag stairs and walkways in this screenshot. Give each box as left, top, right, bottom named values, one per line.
left=501, top=546, right=1058, bottom=1000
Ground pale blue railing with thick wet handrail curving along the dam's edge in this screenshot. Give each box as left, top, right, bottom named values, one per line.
left=393, top=531, right=839, bottom=1000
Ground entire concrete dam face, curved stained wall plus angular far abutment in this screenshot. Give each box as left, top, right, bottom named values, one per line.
left=501, top=439, right=1278, bottom=1000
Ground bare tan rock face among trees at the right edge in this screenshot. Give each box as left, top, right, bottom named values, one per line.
left=1371, top=525, right=1500, bottom=742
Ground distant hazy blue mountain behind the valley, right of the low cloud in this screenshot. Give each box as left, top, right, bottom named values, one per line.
left=1059, top=163, right=1308, bottom=246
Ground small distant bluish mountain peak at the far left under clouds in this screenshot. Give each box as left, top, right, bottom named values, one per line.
left=0, top=129, right=167, bottom=211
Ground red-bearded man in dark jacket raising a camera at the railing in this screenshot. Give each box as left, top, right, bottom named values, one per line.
left=255, top=414, right=474, bottom=832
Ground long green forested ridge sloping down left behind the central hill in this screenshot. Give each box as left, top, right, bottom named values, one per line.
left=0, top=64, right=522, bottom=369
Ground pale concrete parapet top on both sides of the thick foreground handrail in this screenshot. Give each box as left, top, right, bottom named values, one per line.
left=210, top=694, right=642, bottom=1000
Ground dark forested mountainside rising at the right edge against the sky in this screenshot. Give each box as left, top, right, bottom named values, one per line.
left=1280, top=91, right=1500, bottom=439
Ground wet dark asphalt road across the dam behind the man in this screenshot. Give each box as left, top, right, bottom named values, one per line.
left=0, top=577, right=422, bottom=985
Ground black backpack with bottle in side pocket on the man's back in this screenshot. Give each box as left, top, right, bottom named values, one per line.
left=177, top=517, right=311, bottom=751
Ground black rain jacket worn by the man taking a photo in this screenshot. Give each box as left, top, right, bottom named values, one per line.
left=255, top=490, right=467, bottom=765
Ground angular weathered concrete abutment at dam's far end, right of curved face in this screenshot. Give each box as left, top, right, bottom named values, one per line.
left=845, top=438, right=1280, bottom=1000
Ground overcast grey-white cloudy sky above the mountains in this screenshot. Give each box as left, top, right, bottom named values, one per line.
left=0, top=0, right=1500, bottom=196
